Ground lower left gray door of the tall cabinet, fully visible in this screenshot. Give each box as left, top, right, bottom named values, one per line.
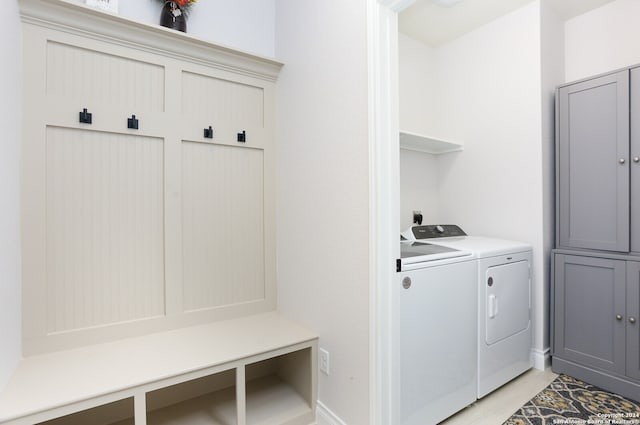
left=554, top=254, right=626, bottom=374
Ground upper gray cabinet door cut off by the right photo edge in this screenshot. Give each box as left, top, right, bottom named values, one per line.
left=629, top=68, right=640, bottom=252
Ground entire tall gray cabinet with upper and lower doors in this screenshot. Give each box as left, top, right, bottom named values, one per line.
left=551, top=66, right=640, bottom=400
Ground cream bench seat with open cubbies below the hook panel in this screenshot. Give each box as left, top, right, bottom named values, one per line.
left=0, top=312, right=318, bottom=425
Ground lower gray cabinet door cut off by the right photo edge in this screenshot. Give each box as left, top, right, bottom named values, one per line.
left=626, top=261, right=640, bottom=379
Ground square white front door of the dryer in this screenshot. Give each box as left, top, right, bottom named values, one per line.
left=484, top=261, right=531, bottom=345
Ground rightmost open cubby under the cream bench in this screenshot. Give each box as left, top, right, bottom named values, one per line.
left=245, top=348, right=313, bottom=425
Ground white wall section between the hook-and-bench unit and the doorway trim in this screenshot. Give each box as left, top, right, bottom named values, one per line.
left=276, top=0, right=370, bottom=425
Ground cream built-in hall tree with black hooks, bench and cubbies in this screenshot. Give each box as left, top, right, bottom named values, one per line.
left=0, top=0, right=318, bottom=425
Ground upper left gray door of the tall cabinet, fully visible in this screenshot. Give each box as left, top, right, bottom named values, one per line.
left=557, top=71, right=629, bottom=252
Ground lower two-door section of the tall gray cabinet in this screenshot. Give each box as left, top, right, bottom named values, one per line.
left=552, top=252, right=640, bottom=400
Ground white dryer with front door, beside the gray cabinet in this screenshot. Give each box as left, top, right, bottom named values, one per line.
left=402, top=225, right=533, bottom=398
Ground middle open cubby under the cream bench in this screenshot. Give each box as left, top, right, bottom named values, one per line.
left=147, top=369, right=237, bottom=425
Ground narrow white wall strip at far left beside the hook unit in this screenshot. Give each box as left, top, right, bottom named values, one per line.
left=0, top=2, right=22, bottom=389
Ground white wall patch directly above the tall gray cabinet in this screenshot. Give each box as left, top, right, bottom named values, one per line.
left=565, top=0, right=640, bottom=82
